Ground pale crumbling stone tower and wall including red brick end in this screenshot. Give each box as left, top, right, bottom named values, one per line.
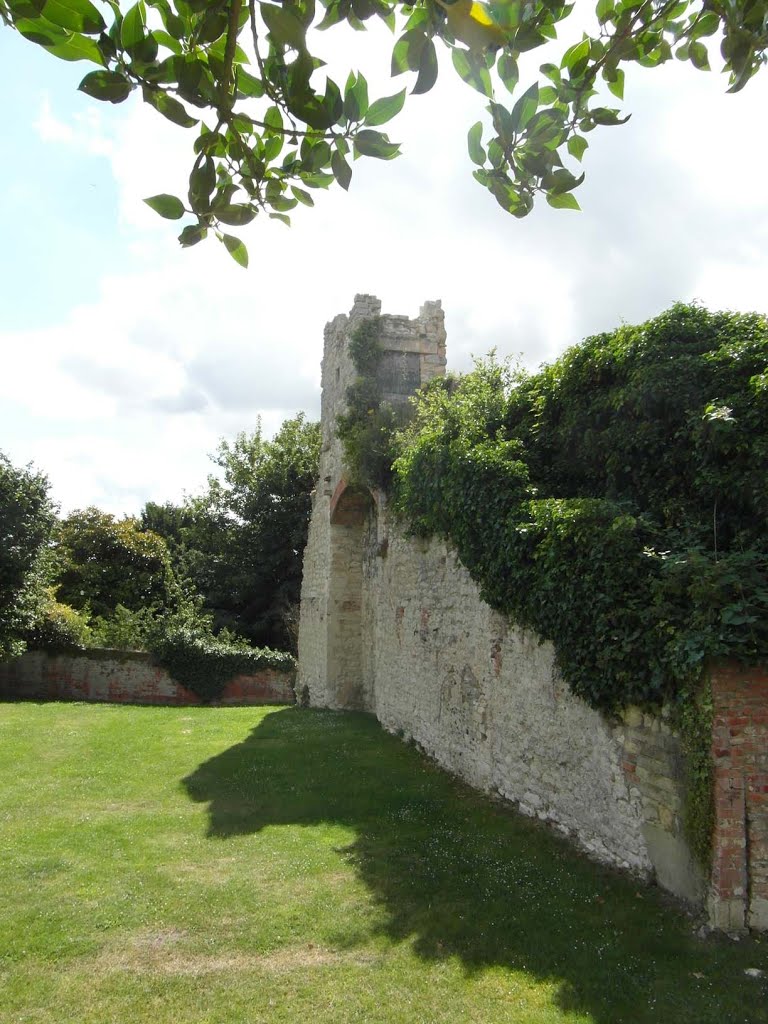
left=296, top=295, right=768, bottom=929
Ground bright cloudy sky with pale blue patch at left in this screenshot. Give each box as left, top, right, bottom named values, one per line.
left=0, top=6, right=768, bottom=515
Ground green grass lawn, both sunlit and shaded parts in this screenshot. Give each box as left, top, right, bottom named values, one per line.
left=0, top=703, right=768, bottom=1024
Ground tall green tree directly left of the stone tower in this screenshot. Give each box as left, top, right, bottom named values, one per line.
left=142, top=413, right=319, bottom=648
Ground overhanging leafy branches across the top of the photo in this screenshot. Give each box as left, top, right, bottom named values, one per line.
left=0, top=0, right=768, bottom=266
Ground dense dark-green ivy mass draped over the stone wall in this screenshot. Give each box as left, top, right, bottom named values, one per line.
left=393, top=305, right=768, bottom=710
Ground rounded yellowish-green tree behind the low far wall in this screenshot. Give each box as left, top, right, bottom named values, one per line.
left=55, top=507, right=175, bottom=618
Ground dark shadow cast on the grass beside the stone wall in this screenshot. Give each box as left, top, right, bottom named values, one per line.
left=183, top=709, right=768, bottom=1024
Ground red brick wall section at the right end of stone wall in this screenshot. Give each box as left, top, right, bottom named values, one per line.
left=710, top=664, right=768, bottom=930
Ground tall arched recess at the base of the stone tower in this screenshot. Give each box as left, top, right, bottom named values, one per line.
left=328, top=480, right=373, bottom=710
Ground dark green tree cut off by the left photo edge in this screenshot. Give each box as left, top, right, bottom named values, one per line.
left=0, top=452, right=55, bottom=659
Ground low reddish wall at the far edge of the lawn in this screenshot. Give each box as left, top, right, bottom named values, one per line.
left=0, top=650, right=294, bottom=706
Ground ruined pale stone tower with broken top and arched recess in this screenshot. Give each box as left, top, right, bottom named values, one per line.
left=296, top=295, right=445, bottom=711
